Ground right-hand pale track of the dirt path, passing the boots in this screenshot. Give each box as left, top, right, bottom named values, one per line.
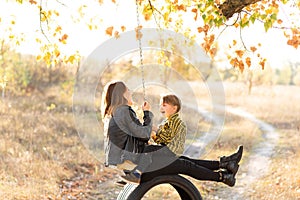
left=206, top=106, right=279, bottom=200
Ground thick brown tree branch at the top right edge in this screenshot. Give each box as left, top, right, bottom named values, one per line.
left=219, top=0, right=261, bottom=19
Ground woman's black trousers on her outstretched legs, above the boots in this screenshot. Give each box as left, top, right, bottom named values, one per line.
left=141, top=148, right=221, bottom=182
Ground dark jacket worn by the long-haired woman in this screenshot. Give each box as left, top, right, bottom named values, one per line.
left=105, top=105, right=153, bottom=165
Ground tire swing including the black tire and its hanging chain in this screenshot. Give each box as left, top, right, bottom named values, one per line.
left=117, top=0, right=202, bottom=200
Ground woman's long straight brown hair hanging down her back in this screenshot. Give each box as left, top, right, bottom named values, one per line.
left=103, top=81, right=128, bottom=117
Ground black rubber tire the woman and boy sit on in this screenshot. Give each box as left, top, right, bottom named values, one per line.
left=118, top=175, right=202, bottom=200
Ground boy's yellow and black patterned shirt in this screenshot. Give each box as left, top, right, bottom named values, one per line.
left=154, top=113, right=187, bottom=156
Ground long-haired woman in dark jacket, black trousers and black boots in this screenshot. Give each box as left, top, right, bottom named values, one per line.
left=105, top=82, right=243, bottom=187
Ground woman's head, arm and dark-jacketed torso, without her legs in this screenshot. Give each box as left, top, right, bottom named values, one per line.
left=103, top=82, right=153, bottom=169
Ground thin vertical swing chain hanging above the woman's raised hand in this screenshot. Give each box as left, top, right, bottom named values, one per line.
left=135, top=0, right=146, bottom=101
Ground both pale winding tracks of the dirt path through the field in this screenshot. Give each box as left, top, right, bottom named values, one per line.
left=180, top=105, right=278, bottom=199
